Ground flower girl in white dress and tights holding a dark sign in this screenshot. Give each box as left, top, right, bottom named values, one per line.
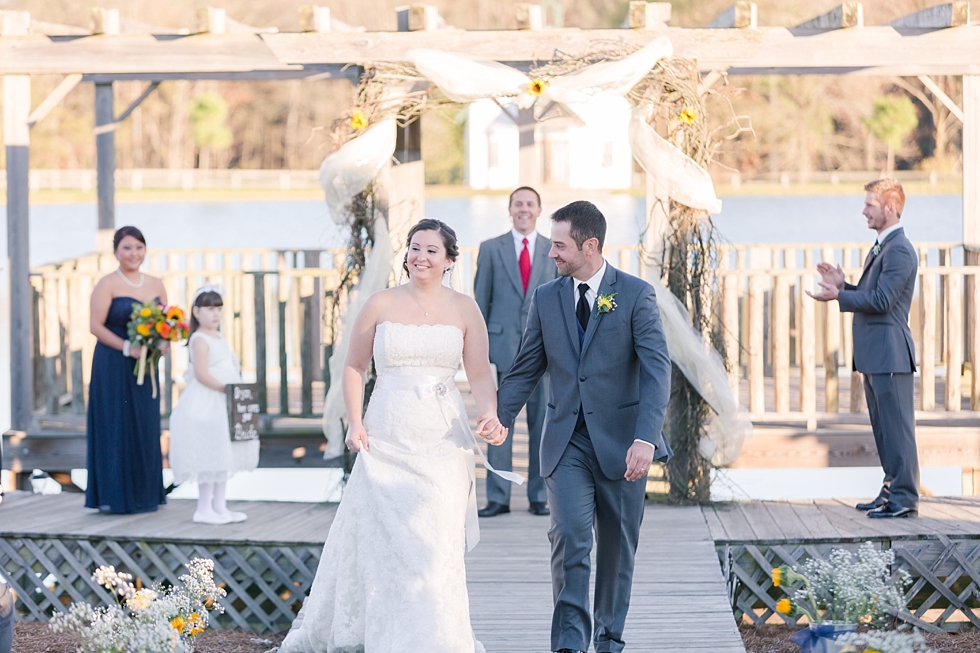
left=170, top=284, right=259, bottom=524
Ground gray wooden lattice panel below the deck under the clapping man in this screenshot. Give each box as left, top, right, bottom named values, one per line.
left=718, top=536, right=980, bottom=632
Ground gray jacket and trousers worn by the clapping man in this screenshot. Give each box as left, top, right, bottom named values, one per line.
left=837, top=227, right=919, bottom=510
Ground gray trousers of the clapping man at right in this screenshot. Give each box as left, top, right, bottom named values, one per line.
left=864, top=373, right=919, bottom=510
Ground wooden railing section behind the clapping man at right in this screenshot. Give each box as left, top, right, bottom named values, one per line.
left=716, top=243, right=980, bottom=429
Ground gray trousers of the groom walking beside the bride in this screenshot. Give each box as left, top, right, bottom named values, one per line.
left=545, top=424, right=646, bottom=653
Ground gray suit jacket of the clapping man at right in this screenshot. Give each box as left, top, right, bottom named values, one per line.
left=837, top=229, right=919, bottom=374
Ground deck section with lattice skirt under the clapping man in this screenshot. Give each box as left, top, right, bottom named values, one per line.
left=702, top=497, right=980, bottom=632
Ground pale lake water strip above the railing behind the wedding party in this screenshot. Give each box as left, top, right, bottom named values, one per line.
left=17, top=193, right=963, bottom=265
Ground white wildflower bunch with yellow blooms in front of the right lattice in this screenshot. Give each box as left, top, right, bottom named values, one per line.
left=772, top=542, right=911, bottom=625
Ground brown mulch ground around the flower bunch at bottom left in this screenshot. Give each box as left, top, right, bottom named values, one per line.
left=13, top=621, right=286, bottom=653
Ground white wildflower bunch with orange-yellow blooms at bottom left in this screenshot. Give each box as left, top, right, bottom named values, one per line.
left=51, top=558, right=225, bottom=653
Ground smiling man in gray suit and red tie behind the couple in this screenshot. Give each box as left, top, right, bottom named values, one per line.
left=473, top=186, right=558, bottom=517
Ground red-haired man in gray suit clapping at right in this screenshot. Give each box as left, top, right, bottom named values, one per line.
left=810, top=179, right=919, bottom=518
